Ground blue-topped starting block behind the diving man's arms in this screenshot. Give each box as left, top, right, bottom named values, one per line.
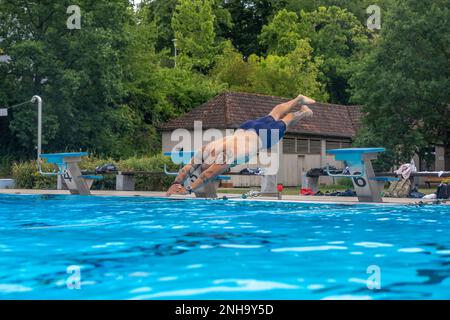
left=164, top=151, right=231, bottom=198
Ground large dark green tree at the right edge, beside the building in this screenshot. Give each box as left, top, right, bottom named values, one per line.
left=351, top=0, right=450, bottom=170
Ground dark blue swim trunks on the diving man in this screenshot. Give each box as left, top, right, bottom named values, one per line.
left=239, top=115, right=286, bottom=149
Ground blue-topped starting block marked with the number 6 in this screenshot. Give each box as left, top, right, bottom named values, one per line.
left=326, top=148, right=397, bottom=202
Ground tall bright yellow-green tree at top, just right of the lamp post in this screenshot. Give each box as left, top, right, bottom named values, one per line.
left=172, top=0, right=217, bottom=73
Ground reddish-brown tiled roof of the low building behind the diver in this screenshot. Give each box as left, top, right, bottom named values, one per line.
left=160, top=92, right=361, bottom=138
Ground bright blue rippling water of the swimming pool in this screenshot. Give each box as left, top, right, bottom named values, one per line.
left=0, top=195, right=450, bottom=299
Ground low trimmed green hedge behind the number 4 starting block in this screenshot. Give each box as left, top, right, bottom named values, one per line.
left=11, top=155, right=177, bottom=191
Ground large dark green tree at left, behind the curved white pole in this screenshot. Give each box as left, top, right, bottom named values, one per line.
left=0, top=0, right=131, bottom=155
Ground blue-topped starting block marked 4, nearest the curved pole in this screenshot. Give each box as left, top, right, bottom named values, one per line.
left=38, top=152, right=103, bottom=195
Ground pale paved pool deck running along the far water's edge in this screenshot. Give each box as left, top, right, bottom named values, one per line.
left=0, top=189, right=450, bottom=205
